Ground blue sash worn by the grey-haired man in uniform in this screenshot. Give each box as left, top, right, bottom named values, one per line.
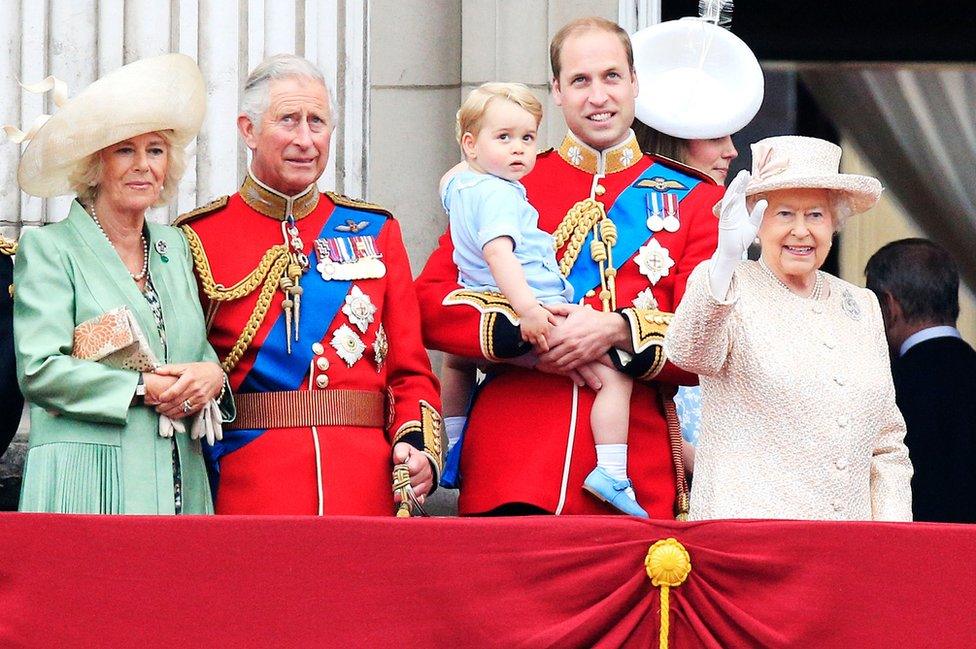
left=207, top=205, right=386, bottom=471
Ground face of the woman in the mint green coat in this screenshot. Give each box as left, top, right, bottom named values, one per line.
left=96, top=133, right=169, bottom=215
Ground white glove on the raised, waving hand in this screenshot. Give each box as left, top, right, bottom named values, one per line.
left=708, top=169, right=768, bottom=301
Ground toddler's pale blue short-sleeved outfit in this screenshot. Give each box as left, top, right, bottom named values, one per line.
left=441, top=171, right=573, bottom=304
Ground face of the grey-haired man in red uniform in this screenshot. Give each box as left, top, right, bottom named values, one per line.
left=237, top=77, right=334, bottom=196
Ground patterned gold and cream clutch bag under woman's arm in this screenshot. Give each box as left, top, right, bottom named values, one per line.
left=71, top=306, right=159, bottom=372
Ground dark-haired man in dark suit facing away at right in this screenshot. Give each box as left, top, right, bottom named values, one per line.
left=864, top=239, right=976, bottom=523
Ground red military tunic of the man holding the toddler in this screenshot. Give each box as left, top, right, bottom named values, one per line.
left=417, top=133, right=723, bottom=518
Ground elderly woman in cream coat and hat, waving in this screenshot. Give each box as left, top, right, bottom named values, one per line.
left=665, top=137, right=912, bottom=521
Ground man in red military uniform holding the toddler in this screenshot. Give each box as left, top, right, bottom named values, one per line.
left=417, top=18, right=722, bottom=518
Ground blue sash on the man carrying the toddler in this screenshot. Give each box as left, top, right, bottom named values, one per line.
left=566, top=162, right=701, bottom=301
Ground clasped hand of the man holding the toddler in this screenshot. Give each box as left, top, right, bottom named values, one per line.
left=536, top=304, right=629, bottom=370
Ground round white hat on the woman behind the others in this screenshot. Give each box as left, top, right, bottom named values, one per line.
left=630, top=18, right=764, bottom=140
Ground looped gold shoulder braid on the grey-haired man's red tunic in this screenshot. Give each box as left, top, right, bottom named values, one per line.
left=180, top=225, right=289, bottom=373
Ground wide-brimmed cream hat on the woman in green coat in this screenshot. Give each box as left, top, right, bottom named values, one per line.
left=17, top=54, right=206, bottom=197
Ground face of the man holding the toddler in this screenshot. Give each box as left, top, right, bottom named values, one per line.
left=552, top=29, right=637, bottom=151
